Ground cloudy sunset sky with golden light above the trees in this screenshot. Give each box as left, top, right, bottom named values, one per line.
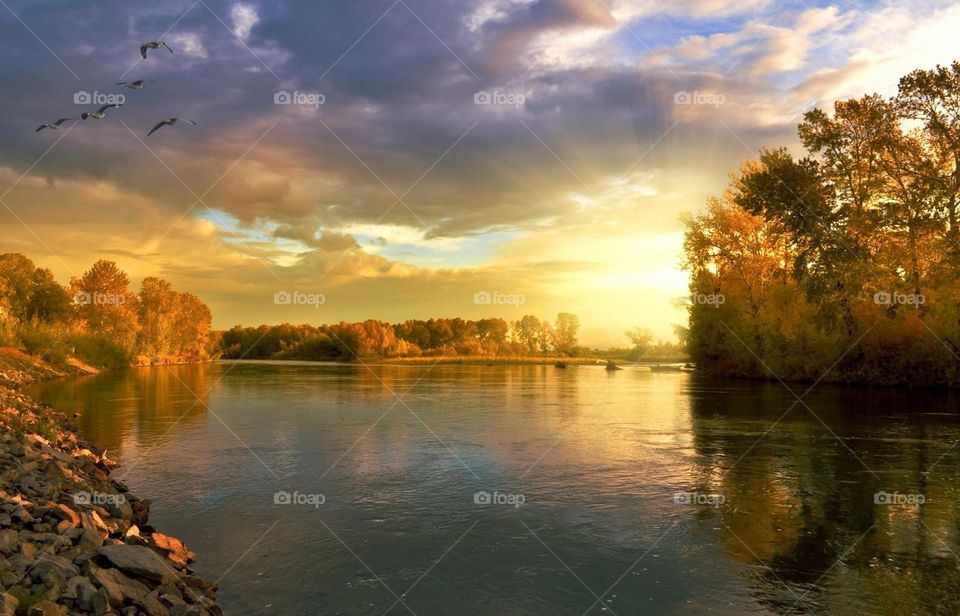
left=0, top=0, right=960, bottom=347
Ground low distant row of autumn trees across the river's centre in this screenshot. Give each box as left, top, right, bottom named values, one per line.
left=221, top=312, right=586, bottom=361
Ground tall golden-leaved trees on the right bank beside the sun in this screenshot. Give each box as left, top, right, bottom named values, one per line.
left=684, top=62, right=960, bottom=385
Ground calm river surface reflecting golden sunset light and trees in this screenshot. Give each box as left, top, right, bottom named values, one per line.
left=24, top=362, right=960, bottom=616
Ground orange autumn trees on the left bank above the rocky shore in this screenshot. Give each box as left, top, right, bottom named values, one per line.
left=0, top=253, right=217, bottom=367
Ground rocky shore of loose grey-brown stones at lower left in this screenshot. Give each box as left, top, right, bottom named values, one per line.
left=0, top=350, right=223, bottom=616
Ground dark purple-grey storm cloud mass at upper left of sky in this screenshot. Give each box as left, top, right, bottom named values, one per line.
left=0, top=0, right=700, bottom=241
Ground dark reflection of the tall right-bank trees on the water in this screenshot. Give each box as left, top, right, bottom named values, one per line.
left=691, top=383, right=960, bottom=614
